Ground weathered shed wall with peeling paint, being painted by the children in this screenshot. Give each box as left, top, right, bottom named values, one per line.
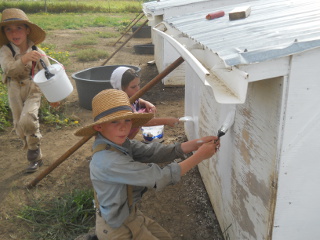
left=185, top=63, right=283, bottom=240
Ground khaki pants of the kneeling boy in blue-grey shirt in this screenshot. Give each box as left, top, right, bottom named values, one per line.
left=96, top=206, right=172, bottom=240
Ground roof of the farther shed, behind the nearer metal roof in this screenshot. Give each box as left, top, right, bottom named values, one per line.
left=143, top=0, right=213, bottom=15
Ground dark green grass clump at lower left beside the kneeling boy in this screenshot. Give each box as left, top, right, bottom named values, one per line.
left=17, top=190, right=95, bottom=240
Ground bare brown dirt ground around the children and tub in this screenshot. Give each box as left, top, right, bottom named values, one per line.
left=0, top=28, right=222, bottom=240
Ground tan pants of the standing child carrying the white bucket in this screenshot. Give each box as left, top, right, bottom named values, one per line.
left=7, top=79, right=42, bottom=154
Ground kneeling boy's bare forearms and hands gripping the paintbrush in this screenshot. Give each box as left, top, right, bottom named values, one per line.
left=179, top=136, right=220, bottom=176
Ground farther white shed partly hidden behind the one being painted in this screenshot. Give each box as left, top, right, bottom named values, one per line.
left=142, top=0, right=254, bottom=86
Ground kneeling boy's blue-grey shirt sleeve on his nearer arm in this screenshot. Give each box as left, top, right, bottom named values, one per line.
left=90, top=150, right=181, bottom=189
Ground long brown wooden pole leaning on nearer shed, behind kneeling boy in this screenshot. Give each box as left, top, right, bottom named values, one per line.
left=27, top=57, right=184, bottom=189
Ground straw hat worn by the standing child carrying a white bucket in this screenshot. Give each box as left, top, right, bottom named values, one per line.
left=0, top=8, right=46, bottom=46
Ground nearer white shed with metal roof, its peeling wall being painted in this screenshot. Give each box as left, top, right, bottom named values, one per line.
left=154, top=0, right=320, bottom=240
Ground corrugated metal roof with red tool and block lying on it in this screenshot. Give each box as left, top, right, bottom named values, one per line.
left=165, top=0, right=320, bottom=66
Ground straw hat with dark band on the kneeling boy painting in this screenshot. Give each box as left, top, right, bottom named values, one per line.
left=75, top=89, right=153, bottom=136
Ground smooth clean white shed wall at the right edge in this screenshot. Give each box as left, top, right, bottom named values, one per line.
left=273, top=49, right=320, bottom=240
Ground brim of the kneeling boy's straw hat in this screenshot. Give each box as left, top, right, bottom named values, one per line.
left=74, top=111, right=154, bottom=137
